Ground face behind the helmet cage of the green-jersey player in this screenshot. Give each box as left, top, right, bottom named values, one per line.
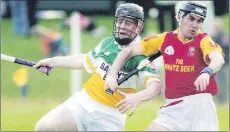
left=115, top=17, right=137, bottom=39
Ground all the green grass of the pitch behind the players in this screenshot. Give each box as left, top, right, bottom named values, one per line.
left=1, top=13, right=229, bottom=131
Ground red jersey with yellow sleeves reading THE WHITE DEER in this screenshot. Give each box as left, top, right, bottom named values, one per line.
left=141, top=29, right=223, bottom=99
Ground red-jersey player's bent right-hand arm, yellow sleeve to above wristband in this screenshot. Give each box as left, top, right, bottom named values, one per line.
left=201, top=36, right=224, bottom=74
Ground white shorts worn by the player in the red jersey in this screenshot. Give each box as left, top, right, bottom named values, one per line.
left=153, top=93, right=218, bottom=131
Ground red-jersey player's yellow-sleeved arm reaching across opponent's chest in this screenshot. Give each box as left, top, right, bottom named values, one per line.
left=106, top=32, right=167, bottom=91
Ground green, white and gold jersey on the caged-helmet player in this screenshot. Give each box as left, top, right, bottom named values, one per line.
left=83, top=37, right=160, bottom=106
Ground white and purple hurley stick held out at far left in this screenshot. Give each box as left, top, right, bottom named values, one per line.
left=1, top=54, right=52, bottom=76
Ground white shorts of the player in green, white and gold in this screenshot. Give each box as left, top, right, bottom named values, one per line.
left=63, top=89, right=126, bottom=131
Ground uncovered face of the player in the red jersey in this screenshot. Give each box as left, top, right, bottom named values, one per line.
left=180, top=14, right=204, bottom=39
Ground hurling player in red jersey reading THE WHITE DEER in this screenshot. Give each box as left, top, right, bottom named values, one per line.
left=106, top=1, right=224, bottom=131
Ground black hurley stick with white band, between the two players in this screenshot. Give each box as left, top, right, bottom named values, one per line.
left=105, top=52, right=161, bottom=95
